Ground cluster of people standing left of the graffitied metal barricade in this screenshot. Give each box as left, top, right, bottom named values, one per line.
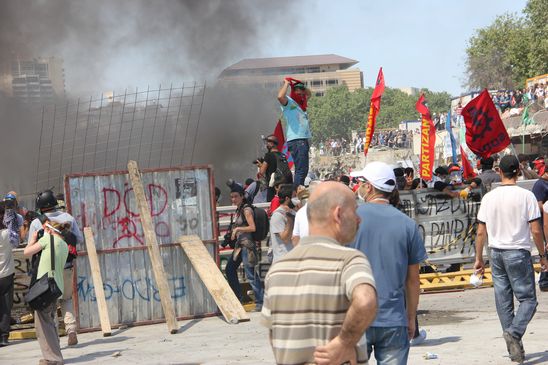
left=0, top=190, right=84, bottom=365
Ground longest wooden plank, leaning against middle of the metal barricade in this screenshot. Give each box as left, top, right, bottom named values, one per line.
left=127, top=161, right=179, bottom=334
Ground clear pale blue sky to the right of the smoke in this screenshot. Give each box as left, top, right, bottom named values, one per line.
left=271, top=0, right=526, bottom=96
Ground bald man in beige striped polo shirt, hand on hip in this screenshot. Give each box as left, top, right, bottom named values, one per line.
left=262, top=182, right=377, bottom=365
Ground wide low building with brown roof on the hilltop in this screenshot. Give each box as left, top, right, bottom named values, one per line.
left=219, top=54, right=363, bottom=96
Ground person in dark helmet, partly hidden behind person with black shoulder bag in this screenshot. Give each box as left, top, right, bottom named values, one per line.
left=28, top=190, right=84, bottom=346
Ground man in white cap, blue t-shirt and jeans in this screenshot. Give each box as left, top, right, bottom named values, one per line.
left=352, top=162, right=427, bottom=365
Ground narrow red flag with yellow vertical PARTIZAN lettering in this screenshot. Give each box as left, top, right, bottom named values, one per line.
left=415, top=94, right=436, bottom=180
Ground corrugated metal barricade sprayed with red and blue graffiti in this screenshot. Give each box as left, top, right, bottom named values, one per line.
left=65, top=166, right=218, bottom=330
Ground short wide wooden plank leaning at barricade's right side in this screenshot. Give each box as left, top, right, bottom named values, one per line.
left=180, top=235, right=249, bottom=323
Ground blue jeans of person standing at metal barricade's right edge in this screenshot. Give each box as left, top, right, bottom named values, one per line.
left=225, top=248, right=264, bottom=308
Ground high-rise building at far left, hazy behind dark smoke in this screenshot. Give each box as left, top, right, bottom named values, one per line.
left=11, top=57, right=65, bottom=104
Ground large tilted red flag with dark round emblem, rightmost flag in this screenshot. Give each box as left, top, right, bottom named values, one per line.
left=462, top=89, right=510, bottom=158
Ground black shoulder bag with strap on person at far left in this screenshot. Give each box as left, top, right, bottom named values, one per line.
left=25, top=235, right=63, bottom=311
